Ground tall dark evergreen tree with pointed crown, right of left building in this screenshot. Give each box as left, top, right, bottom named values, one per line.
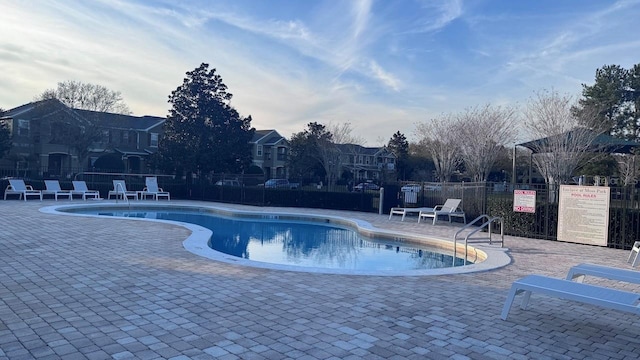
left=158, top=63, right=255, bottom=175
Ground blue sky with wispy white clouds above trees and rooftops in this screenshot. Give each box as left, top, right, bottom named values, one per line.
left=0, top=0, right=640, bottom=146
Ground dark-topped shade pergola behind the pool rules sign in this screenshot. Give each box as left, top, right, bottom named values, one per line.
left=511, top=129, right=640, bottom=184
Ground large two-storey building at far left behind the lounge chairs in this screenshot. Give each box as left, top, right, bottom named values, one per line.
left=0, top=99, right=165, bottom=177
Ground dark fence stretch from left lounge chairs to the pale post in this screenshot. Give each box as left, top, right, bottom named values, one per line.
left=0, top=169, right=388, bottom=212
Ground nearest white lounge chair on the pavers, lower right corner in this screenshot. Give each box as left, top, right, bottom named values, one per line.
left=500, top=275, right=640, bottom=320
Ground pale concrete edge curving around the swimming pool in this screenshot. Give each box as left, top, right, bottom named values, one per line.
left=39, top=202, right=511, bottom=276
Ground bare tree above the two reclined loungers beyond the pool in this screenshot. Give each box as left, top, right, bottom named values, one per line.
left=415, top=114, right=461, bottom=182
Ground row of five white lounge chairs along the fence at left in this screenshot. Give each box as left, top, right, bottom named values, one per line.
left=4, top=177, right=171, bottom=201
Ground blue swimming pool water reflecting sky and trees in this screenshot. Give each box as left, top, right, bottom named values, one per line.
left=74, top=209, right=469, bottom=271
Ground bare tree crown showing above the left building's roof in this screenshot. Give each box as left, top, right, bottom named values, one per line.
left=35, top=80, right=131, bottom=115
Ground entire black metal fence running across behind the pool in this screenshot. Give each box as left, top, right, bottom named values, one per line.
left=0, top=169, right=640, bottom=249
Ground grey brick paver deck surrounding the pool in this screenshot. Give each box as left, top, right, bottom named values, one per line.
left=0, top=200, right=640, bottom=359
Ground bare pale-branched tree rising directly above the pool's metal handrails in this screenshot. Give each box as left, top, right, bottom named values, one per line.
left=456, top=105, right=517, bottom=181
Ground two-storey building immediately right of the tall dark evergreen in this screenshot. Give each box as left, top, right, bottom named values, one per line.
left=251, top=130, right=289, bottom=179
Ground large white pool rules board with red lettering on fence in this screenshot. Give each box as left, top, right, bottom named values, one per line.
left=558, top=185, right=611, bottom=246
